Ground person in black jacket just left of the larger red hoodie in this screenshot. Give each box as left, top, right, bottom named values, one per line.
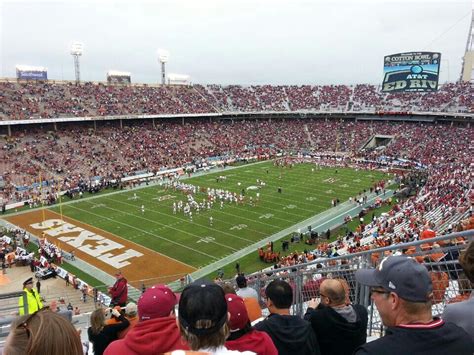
left=87, top=308, right=130, bottom=355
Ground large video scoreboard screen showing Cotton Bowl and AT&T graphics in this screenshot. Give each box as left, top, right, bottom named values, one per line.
left=382, top=52, right=441, bottom=92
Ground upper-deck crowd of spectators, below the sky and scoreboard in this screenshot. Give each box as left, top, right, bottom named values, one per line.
left=0, top=82, right=474, bottom=120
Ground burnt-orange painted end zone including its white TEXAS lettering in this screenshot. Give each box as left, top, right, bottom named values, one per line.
left=4, top=210, right=196, bottom=287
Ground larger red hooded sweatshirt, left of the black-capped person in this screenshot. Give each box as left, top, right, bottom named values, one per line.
left=104, top=316, right=189, bottom=355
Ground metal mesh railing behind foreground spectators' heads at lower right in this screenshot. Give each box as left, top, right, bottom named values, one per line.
left=239, top=230, right=474, bottom=336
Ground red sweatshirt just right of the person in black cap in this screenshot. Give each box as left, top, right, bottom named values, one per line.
left=225, top=329, right=278, bottom=355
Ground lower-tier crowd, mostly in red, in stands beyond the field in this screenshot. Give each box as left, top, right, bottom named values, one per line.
left=0, top=119, right=474, bottom=205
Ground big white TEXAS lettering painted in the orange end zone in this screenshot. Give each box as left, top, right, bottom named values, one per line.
left=30, top=219, right=143, bottom=269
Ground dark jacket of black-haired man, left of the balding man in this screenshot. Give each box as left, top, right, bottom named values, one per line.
left=255, top=314, right=320, bottom=355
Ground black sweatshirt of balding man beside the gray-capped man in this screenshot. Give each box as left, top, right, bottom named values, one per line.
left=304, top=303, right=368, bottom=355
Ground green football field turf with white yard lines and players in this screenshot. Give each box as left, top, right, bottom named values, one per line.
left=53, top=162, right=388, bottom=268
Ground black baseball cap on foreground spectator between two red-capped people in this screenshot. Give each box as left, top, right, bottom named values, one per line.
left=178, top=280, right=227, bottom=336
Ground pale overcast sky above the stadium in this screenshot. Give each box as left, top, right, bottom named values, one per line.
left=0, top=0, right=472, bottom=85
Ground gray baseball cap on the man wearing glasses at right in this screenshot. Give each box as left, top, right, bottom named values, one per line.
left=355, top=256, right=433, bottom=302
